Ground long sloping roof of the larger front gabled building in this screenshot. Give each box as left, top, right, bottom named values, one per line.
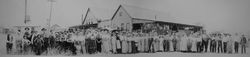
left=111, top=4, right=201, bottom=25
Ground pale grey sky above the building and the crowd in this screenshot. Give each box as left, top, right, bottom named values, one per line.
left=0, top=0, right=250, bottom=34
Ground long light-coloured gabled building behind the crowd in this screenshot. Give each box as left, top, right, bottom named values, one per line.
left=77, top=5, right=202, bottom=31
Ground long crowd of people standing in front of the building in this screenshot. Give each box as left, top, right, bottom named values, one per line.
left=6, top=28, right=247, bottom=55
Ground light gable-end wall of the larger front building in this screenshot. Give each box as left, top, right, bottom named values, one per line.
left=111, top=7, right=132, bottom=31
